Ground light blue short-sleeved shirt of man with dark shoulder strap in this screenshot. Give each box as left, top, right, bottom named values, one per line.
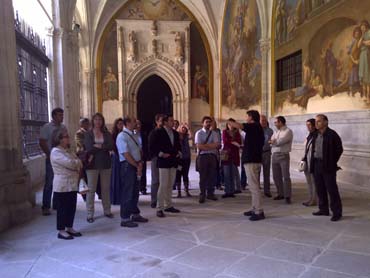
left=116, top=128, right=141, bottom=162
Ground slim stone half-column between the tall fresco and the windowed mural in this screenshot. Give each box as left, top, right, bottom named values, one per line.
left=260, top=38, right=273, bottom=117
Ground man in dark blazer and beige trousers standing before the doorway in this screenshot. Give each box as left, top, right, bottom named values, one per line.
left=157, top=115, right=181, bottom=217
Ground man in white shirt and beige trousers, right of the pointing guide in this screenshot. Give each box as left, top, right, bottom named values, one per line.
left=269, top=116, right=293, bottom=204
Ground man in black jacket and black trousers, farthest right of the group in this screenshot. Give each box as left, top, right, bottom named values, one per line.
left=310, top=114, right=343, bottom=221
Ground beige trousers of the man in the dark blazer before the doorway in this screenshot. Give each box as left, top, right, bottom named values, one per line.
left=157, top=168, right=176, bottom=210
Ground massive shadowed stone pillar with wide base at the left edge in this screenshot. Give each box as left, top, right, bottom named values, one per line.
left=0, top=0, right=32, bottom=231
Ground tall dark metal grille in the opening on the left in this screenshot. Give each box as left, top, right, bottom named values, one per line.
left=15, top=12, right=49, bottom=158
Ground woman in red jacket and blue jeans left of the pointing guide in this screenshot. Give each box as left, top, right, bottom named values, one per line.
left=220, top=118, right=242, bottom=198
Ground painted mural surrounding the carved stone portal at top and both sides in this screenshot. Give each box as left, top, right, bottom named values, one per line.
left=100, top=0, right=210, bottom=108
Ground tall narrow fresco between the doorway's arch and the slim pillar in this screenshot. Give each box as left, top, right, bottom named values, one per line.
left=221, top=0, right=261, bottom=118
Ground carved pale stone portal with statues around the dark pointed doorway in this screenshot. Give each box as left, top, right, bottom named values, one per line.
left=116, top=19, right=191, bottom=122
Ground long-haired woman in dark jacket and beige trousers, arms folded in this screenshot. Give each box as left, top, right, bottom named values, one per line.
left=84, top=113, right=113, bottom=223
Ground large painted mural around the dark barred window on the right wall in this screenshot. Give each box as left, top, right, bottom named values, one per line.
left=274, top=0, right=370, bottom=114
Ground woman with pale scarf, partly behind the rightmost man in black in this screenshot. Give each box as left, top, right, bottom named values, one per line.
left=299, top=119, right=317, bottom=207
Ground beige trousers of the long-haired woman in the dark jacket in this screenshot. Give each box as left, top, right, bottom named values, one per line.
left=86, top=169, right=111, bottom=218
